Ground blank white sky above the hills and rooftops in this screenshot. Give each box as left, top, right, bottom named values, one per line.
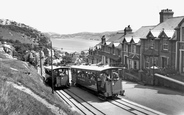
left=0, top=0, right=184, bottom=34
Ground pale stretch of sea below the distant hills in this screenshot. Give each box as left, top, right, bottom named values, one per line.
left=51, top=38, right=100, bottom=53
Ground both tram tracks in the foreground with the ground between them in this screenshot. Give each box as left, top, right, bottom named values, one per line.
left=56, top=89, right=163, bottom=115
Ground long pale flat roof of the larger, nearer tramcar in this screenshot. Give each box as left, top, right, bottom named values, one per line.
left=71, top=65, right=123, bottom=71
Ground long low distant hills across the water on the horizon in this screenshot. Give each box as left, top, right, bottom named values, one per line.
left=44, top=32, right=117, bottom=41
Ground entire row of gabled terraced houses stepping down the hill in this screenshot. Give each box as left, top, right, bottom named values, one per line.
left=90, top=9, right=184, bottom=73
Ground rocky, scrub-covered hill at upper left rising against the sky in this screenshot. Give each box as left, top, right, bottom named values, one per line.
left=0, top=19, right=50, bottom=44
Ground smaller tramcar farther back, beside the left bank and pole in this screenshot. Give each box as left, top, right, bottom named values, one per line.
left=45, top=66, right=71, bottom=88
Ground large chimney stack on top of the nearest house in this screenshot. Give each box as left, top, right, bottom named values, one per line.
left=159, top=9, right=174, bottom=23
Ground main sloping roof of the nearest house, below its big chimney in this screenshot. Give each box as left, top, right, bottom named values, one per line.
left=153, top=16, right=184, bottom=30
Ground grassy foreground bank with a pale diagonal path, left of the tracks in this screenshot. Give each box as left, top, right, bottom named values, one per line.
left=0, top=53, right=78, bottom=115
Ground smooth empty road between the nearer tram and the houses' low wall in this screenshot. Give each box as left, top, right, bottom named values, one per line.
left=122, top=81, right=184, bottom=115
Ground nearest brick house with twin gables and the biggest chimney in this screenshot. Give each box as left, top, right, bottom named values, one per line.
left=141, top=9, right=184, bottom=72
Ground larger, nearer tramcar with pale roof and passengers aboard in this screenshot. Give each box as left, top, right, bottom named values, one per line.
left=71, top=65, right=124, bottom=99
